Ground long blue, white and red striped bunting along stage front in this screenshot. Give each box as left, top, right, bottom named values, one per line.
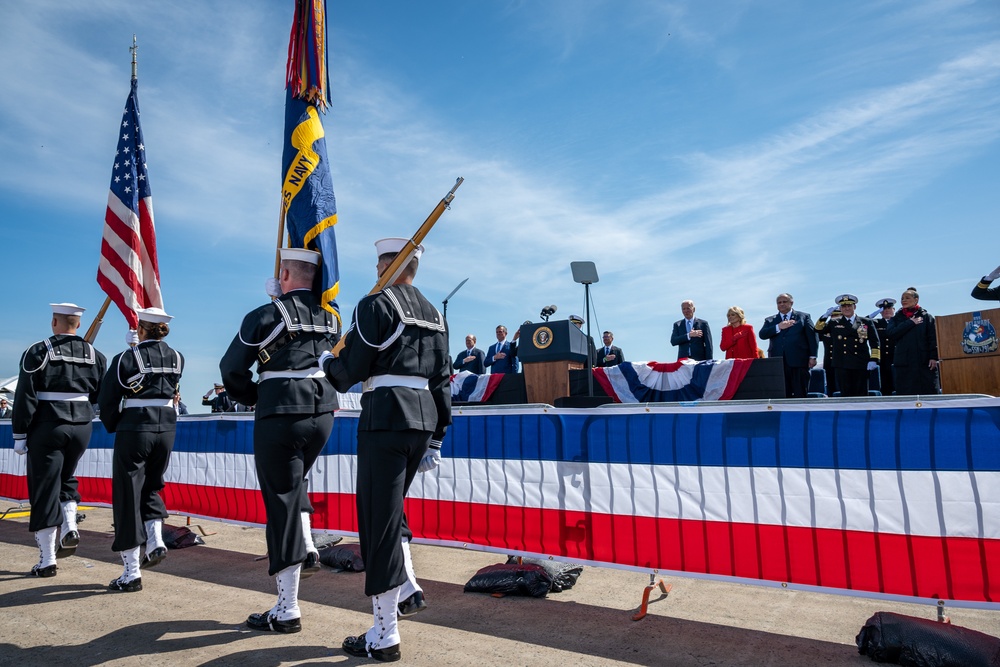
left=0, top=399, right=1000, bottom=609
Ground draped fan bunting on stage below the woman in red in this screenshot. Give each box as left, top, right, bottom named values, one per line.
left=594, top=359, right=752, bottom=403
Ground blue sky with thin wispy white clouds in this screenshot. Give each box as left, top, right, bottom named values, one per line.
left=0, top=0, right=1000, bottom=410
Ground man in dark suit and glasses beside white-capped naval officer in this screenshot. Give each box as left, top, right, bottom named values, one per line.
left=757, top=294, right=818, bottom=398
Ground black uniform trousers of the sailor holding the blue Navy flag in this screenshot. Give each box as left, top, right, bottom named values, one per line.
left=253, top=412, right=333, bottom=576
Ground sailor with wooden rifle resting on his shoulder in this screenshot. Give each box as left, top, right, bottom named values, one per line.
left=320, top=238, right=451, bottom=662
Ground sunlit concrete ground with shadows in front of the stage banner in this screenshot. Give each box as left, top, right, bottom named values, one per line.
left=0, top=501, right=1000, bottom=667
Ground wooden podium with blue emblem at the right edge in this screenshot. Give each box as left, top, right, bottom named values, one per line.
left=935, top=308, right=1000, bottom=396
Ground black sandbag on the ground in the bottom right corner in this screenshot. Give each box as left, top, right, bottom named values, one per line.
left=855, top=611, right=1000, bottom=667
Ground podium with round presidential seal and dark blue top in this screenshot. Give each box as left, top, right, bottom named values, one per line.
left=517, top=320, right=588, bottom=405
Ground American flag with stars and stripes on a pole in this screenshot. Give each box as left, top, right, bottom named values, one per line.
left=97, top=78, right=163, bottom=329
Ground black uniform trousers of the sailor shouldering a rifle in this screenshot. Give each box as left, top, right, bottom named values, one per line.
left=355, top=429, right=432, bottom=595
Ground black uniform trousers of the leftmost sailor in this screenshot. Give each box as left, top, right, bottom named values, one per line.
left=27, top=421, right=93, bottom=533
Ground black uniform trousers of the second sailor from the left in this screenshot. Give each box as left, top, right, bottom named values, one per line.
left=111, top=429, right=175, bottom=551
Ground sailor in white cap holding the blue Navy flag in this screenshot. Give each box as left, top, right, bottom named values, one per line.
left=219, top=248, right=340, bottom=632
